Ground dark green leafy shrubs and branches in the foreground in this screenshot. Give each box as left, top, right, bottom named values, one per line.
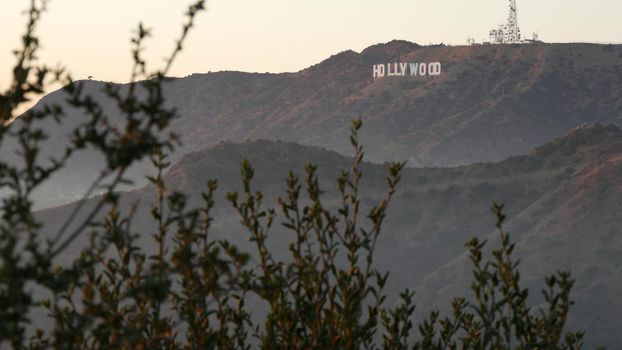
left=0, top=0, right=582, bottom=349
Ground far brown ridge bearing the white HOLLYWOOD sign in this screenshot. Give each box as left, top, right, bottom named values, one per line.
left=0, top=41, right=622, bottom=206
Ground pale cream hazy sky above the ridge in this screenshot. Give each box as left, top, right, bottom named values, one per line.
left=0, top=0, right=622, bottom=88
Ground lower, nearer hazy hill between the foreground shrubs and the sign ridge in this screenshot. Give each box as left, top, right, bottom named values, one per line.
left=38, top=124, right=622, bottom=349
